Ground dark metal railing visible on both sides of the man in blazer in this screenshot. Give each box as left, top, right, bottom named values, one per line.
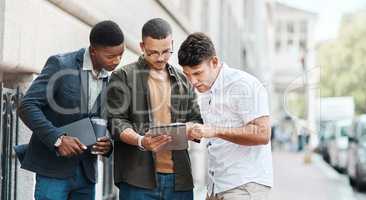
left=0, top=82, right=118, bottom=200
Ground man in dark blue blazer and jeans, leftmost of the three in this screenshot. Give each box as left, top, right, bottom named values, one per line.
left=18, top=21, right=124, bottom=200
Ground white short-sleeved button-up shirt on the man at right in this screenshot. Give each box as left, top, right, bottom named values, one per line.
left=198, top=64, right=273, bottom=193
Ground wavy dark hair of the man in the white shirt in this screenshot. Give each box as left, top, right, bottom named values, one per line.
left=178, top=32, right=216, bottom=66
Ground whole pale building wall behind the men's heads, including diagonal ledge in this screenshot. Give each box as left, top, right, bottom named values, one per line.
left=0, top=0, right=202, bottom=72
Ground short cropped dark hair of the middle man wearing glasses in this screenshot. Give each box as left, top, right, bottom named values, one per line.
left=142, top=18, right=172, bottom=40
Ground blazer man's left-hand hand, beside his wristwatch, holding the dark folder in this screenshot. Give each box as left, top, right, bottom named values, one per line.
left=57, top=136, right=87, bottom=157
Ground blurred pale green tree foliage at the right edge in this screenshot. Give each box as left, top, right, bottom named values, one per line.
left=317, top=11, right=366, bottom=114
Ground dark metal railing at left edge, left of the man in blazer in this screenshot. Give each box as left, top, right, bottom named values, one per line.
left=0, top=82, right=21, bottom=200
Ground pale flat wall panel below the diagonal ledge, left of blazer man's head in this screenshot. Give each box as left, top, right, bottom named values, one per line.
left=1, top=0, right=89, bottom=72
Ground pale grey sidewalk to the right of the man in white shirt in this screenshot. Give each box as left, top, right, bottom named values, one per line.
left=269, top=152, right=355, bottom=200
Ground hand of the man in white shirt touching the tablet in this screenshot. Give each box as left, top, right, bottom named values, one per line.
left=187, top=124, right=216, bottom=140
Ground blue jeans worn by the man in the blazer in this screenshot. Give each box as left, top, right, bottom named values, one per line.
left=34, top=165, right=95, bottom=200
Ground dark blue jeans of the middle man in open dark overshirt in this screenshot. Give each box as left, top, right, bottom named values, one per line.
left=118, top=173, right=193, bottom=200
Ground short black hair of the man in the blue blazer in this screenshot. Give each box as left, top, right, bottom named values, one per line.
left=89, top=20, right=124, bottom=47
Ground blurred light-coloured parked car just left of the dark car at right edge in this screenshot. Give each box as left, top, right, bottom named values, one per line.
left=328, top=119, right=352, bottom=173
